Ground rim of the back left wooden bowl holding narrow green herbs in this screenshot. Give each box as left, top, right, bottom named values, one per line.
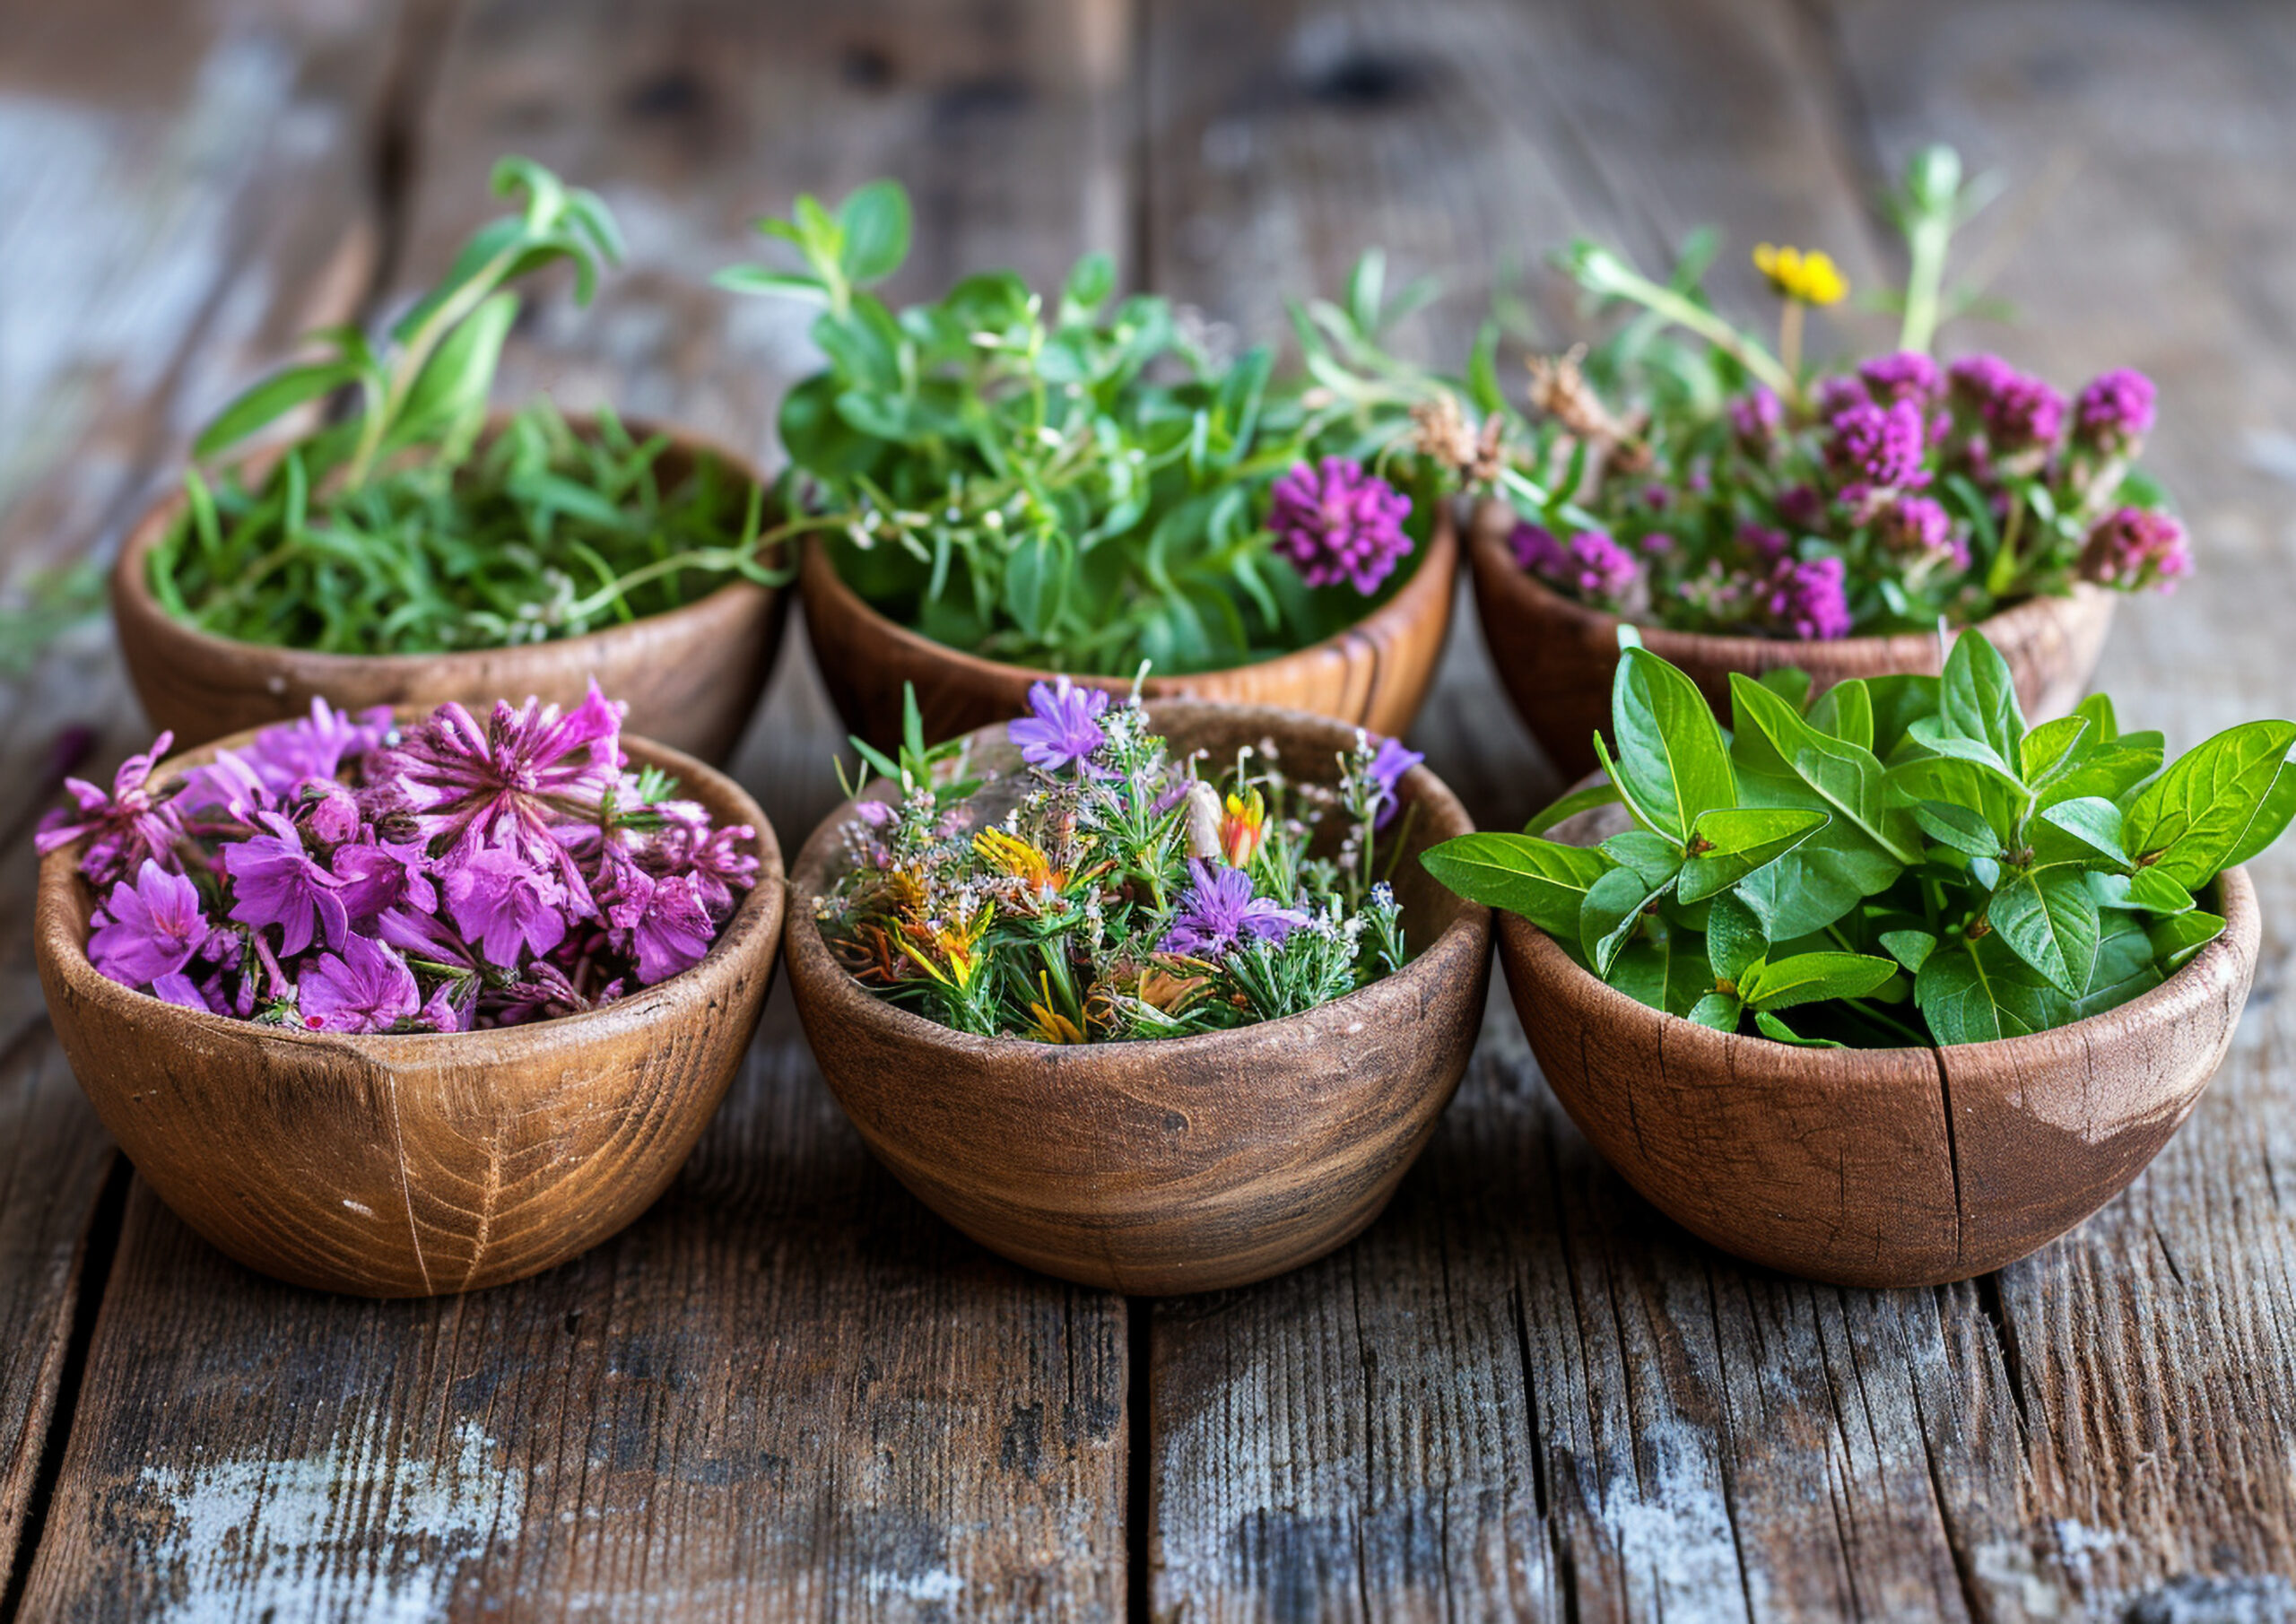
left=108, top=413, right=795, bottom=682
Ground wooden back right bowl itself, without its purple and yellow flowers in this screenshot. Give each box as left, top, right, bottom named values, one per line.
left=1467, top=503, right=2119, bottom=778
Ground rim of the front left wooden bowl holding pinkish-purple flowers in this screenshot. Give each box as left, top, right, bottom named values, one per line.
left=32, top=705, right=787, bottom=1064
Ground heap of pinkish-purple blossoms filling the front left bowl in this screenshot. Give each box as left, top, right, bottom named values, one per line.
left=37, top=684, right=758, bottom=1034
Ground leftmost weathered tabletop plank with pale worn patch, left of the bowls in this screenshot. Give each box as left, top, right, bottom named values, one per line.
left=0, top=3, right=404, bottom=1592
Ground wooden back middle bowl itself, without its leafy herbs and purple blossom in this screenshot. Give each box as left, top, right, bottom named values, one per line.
left=799, top=503, right=1458, bottom=749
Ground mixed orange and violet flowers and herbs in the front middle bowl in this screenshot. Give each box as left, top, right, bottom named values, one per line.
left=820, top=678, right=1419, bottom=1043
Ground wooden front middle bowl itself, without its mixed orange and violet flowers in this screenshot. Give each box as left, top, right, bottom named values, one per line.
left=786, top=700, right=1490, bottom=1296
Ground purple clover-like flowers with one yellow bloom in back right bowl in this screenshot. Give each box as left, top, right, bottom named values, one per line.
left=1510, top=149, right=2193, bottom=641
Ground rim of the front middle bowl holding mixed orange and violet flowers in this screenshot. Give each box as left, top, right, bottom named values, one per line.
left=783, top=696, right=1495, bottom=1073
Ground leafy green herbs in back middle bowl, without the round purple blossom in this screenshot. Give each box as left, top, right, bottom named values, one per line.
left=717, top=181, right=1474, bottom=673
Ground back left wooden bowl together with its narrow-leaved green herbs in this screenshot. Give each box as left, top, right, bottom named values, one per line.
left=112, top=159, right=790, bottom=760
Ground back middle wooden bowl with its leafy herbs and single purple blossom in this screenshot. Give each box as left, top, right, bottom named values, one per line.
left=718, top=181, right=1490, bottom=749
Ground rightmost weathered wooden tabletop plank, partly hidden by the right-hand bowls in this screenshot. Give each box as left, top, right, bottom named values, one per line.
left=1832, top=3, right=2296, bottom=1617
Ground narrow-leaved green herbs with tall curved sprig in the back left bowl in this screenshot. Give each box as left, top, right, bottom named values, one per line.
left=149, top=159, right=787, bottom=655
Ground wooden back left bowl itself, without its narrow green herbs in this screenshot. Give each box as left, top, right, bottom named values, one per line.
left=112, top=416, right=790, bottom=762
